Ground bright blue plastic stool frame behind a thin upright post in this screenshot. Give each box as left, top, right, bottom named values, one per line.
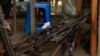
left=25, top=2, right=51, bottom=32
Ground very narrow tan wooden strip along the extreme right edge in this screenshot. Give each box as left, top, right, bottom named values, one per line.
left=97, top=0, right=100, bottom=56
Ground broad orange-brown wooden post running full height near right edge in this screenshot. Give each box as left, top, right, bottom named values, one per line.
left=90, top=0, right=97, bottom=56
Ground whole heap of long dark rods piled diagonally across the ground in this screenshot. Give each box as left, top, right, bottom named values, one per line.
left=0, top=13, right=89, bottom=56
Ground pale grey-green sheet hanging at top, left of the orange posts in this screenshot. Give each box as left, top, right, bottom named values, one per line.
left=62, top=0, right=76, bottom=20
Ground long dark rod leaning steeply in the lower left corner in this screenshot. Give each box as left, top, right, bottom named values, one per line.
left=0, top=17, right=15, bottom=56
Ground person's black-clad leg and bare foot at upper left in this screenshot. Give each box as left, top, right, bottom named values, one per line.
left=1, top=0, right=11, bottom=31
